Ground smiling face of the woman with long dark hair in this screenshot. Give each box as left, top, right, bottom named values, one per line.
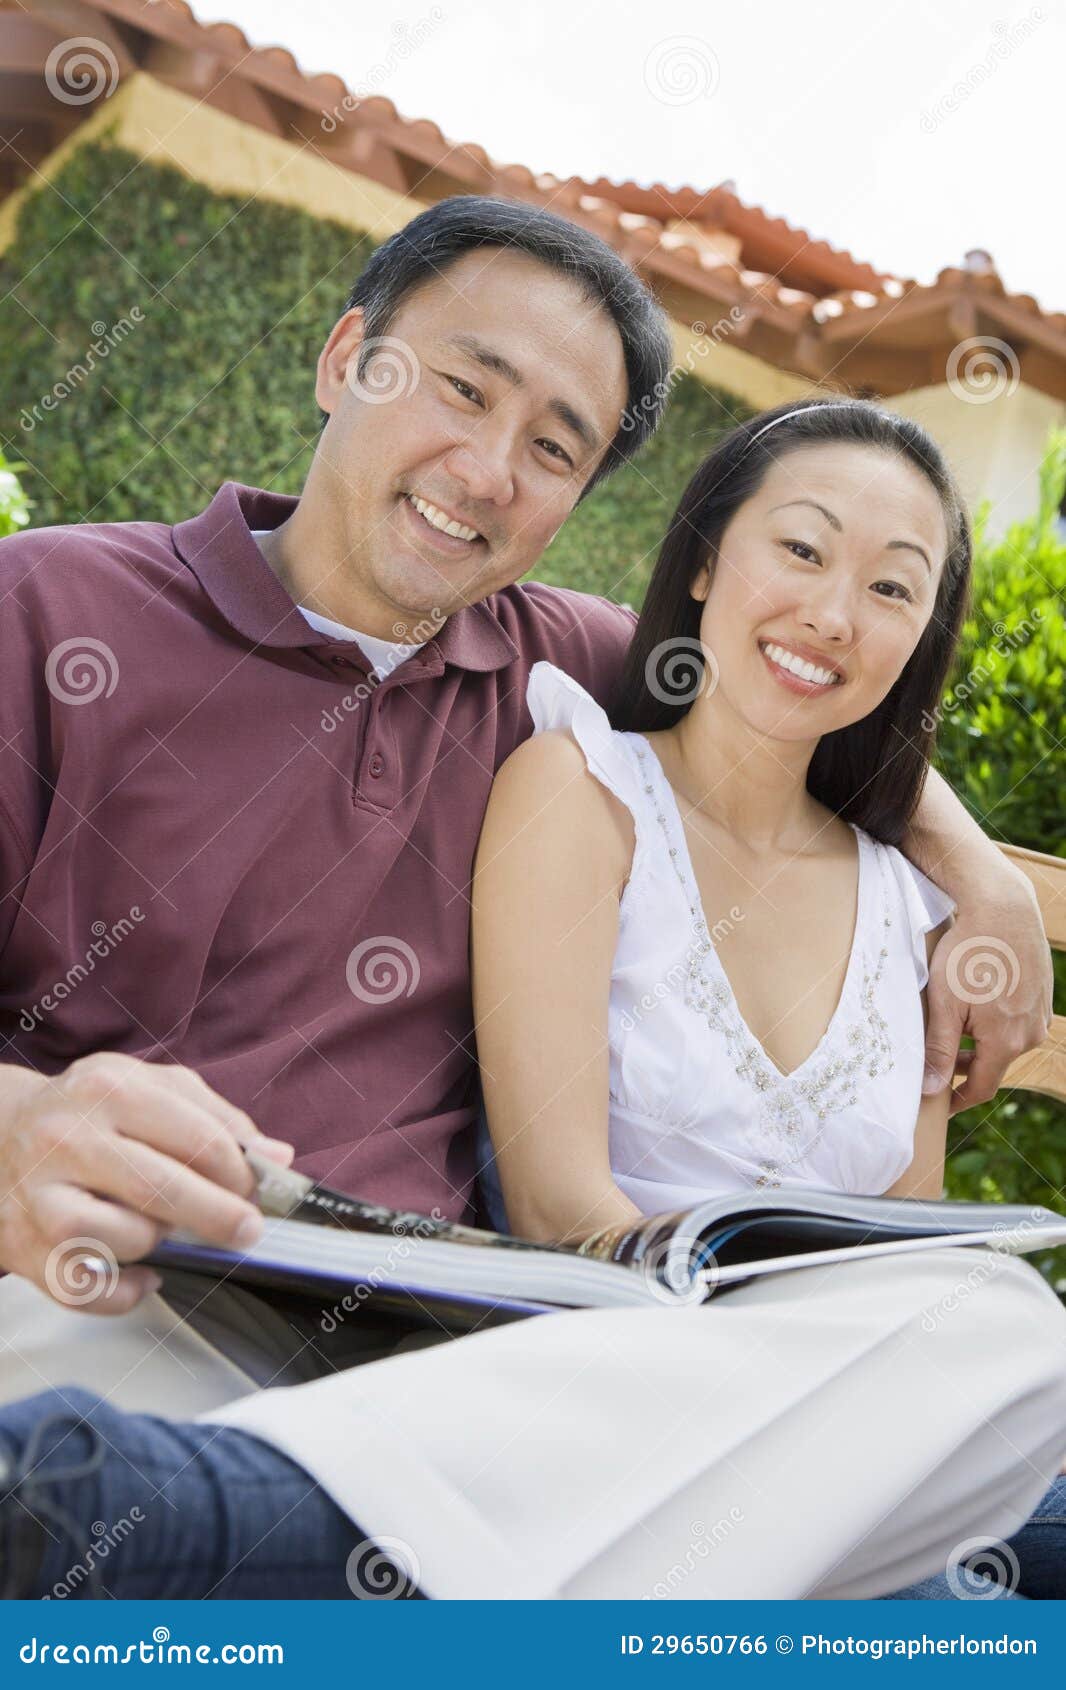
left=691, top=443, right=948, bottom=740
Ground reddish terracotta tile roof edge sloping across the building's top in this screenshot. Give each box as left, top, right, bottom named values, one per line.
left=0, top=0, right=1066, bottom=397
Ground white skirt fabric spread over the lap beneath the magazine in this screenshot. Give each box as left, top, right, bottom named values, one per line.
left=198, top=1247, right=1066, bottom=1599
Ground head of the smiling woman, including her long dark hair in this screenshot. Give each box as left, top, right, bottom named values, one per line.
left=612, top=399, right=971, bottom=843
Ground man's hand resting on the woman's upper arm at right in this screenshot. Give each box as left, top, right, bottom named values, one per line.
left=922, top=852, right=1052, bottom=1115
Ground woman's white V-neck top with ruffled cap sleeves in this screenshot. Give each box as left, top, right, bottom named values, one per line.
left=525, top=662, right=955, bottom=1213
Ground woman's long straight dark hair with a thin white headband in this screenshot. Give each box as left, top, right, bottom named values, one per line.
left=610, top=399, right=973, bottom=845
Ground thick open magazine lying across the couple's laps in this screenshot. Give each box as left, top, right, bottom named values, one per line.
left=145, top=1153, right=1066, bottom=1330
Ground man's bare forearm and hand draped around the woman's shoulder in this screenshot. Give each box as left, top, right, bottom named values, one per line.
left=900, top=769, right=1052, bottom=1114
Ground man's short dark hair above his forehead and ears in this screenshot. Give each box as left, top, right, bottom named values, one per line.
left=337, top=194, right=672, bottom=499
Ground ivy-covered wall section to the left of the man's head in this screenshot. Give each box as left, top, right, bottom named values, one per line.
left=0, top=142, right=381, bottom=524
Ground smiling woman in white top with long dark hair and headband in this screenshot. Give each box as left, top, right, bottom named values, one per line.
left=473, top=401, right=970, bottom=1242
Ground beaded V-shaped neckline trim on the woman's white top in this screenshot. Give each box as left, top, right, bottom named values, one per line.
left=634, top=733, right=892, bottom=1095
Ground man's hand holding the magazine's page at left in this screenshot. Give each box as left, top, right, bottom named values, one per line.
left=0, top=1051, right=292, bottom=1315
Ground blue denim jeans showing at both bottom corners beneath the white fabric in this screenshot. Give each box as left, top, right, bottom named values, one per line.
left=0, top=1386, right=1066, bottom=1600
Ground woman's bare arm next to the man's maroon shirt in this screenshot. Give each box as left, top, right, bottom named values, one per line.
left=471, top=732, right=640, bottom=1244
